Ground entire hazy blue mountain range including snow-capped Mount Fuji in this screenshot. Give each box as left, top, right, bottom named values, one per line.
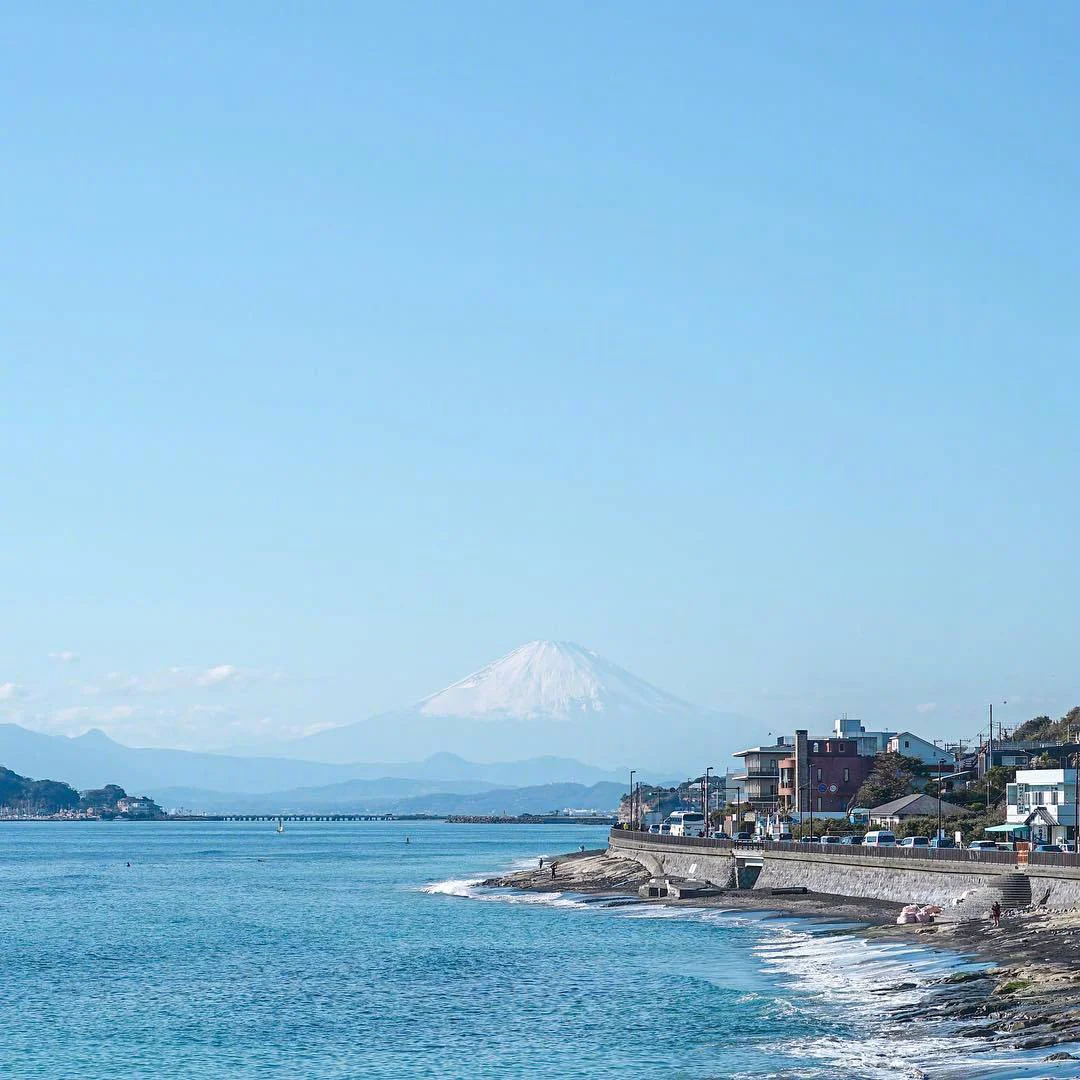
left=0, top=642, right=740, bottom=813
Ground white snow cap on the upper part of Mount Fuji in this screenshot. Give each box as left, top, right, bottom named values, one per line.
left=417, top=642, right=692, bottom=721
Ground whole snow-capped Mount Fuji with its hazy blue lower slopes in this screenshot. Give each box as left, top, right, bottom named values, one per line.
left=282, top=642, right=739, bottom=774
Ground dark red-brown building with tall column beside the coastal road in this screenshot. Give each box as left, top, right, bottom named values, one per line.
left=778, top=721, right=874, bottom=814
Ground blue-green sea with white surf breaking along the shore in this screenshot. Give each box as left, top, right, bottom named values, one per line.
left=0, top=822, right=1069, bottom=1080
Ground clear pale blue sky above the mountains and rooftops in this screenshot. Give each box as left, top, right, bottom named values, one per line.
left=0, top=0, right=1080, bottom=746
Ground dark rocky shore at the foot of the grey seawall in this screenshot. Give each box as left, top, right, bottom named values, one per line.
left=482, top=850, right=1080, bottom=1062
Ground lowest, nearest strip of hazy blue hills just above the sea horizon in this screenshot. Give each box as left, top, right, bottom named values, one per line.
left=156, top=780, right=626, bottom=814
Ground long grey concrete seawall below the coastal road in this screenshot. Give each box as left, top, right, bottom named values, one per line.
left=608, top=831, right=1080, bottom=907
